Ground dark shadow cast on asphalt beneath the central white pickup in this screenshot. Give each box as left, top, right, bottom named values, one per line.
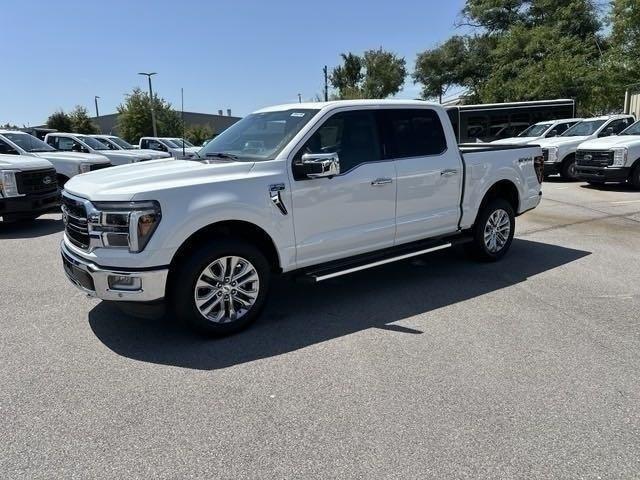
left=89, top=239, right=590, bottom=370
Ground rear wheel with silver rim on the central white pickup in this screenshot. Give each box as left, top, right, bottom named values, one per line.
left=469, top=198, right=516, bottom=262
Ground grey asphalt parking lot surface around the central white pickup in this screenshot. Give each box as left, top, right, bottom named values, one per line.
left=0, top=180, right=640, bottom=479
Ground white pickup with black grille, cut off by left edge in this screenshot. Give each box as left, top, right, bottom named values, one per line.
left=0, top=154, right=60, bottom=222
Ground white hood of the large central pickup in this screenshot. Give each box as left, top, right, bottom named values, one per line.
left=64, top=159, right=254, bottom=201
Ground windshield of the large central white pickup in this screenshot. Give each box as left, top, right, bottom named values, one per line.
left=199, top=108, right=318, bottom=160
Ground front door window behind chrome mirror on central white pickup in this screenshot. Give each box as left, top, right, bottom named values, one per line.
left=296, top=111, right=382, bottom=173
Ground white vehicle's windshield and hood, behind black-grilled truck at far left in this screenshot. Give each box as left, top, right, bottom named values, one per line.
left=0, top=130, right=111, bottom=186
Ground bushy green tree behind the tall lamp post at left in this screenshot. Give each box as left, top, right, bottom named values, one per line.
left=118, top=88, right=182, bottom=142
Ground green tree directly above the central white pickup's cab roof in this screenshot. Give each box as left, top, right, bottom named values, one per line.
left=330, top=48, right=407, bottom=99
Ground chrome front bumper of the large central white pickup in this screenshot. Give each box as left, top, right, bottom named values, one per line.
left=60, top=241, right=169, bottom=302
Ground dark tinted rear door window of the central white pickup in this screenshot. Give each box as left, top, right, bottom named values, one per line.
left=385, top=109, right=447, bottom=158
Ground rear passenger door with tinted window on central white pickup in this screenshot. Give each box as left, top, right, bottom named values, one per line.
left=382, top=108, right=463, bottom=244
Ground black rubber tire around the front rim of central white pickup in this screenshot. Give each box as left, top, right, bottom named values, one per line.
left=169, top=239, right=271, bottom=336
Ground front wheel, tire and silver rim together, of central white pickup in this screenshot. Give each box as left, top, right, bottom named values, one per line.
left=172, top=240, right=271, bottom=336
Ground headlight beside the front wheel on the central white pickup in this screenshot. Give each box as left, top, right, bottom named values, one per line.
left=89, top=201, right=162, bottom=253
